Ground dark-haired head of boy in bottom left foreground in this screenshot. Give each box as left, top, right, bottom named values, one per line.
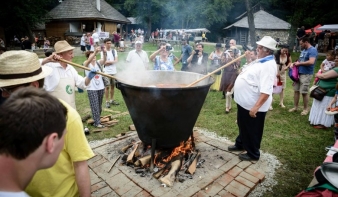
left=0, top=86, right=67, bottom=169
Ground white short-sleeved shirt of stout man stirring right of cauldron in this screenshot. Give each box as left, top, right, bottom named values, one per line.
left=234, top=56, right=277, bottom=112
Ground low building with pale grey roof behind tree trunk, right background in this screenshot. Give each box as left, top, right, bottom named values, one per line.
left=224, top=10, right=291, bottom=44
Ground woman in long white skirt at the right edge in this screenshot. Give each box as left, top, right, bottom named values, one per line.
left=309, top=55, right=338, bottom=129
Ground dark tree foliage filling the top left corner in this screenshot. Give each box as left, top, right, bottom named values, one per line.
left=0, top=0, right=58, bottom=41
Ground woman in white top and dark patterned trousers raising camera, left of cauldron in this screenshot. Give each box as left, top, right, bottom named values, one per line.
left=83, top=47, right=107, bottom=128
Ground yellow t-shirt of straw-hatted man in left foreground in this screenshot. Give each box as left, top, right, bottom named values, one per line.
left=25, top=100, right=94, bottom=197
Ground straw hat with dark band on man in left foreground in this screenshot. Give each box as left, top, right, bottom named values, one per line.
left=0, top=50, right=53, bottom=87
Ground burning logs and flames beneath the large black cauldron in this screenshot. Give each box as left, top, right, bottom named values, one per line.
left=119, top=138, right=205, bottom=187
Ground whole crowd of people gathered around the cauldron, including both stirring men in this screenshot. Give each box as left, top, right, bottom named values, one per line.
left=0, top=25, right=338, bottom=196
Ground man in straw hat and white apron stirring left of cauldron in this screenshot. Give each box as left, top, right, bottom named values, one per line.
left=41, top=40, right=96, bottom=109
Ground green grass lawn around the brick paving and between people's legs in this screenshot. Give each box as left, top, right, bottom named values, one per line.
left=73, top=43, right=333, bottom=196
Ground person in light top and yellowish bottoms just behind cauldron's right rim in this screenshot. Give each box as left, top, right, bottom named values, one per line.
left=208, top=43, right=223, bottom=91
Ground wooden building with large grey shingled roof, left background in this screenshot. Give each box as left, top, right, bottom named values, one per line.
left=46, top=0, right=131, bottom=39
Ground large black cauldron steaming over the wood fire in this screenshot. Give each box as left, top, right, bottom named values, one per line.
left=116, top=71, right=214, bottom=148
